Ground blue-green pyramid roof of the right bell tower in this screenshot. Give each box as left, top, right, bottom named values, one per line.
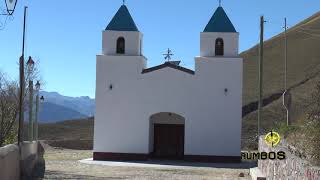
left=203, top=6, right=236, bottom=32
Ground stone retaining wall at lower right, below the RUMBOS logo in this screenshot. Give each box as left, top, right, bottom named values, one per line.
left=258, top=137, right=320, bottom=180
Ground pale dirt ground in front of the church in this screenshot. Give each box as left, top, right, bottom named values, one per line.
left=44, top=148, right=250, bottom=180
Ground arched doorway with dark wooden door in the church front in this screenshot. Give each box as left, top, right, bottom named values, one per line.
left=149, top=112, right=185, bottom=159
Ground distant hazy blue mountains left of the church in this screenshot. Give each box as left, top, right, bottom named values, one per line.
left=35, top=91, right=95, bottom=123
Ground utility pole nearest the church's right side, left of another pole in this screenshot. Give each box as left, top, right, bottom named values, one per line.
left=258, top=16, right=264, bottom=141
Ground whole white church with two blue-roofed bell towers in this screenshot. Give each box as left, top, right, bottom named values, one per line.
left=93, top=5, right=243, bottom=162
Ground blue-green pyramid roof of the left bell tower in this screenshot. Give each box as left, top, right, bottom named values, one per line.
left=106, top=5, right=139, bottom=31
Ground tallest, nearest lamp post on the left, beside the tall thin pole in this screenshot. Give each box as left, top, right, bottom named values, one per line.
left=27, top=56, right=34, bottom=141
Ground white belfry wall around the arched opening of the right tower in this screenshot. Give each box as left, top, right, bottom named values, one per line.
left=200, top=32, right=239, bottom=57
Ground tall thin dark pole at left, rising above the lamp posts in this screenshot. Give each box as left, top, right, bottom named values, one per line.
left=18, top=6, right=28, bottom=146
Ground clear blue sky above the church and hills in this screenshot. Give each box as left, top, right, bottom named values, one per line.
left=0, top=0, right=320, bottom=97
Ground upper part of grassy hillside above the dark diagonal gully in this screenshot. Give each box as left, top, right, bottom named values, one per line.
left=240, top=12, right=320, bottom=104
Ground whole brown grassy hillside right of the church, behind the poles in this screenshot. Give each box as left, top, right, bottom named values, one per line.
left=241, top=12, right=320, bottom=149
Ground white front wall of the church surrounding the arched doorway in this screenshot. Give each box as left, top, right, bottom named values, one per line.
left=94, top=29, right=242, bottom=156
